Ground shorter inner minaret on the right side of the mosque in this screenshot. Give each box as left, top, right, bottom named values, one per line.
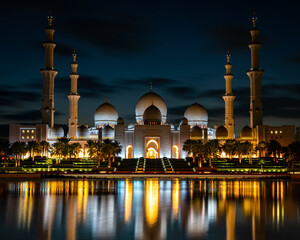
left=223, top=51, right=235, bottom=139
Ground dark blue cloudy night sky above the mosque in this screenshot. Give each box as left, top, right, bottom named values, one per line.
left=0, top=0, right=300, bottom=136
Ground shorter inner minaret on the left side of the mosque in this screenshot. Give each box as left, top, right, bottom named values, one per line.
left=68, top=50, right=80, bottom=138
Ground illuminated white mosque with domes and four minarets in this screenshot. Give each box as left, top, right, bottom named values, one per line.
left=9, top=14, right=295, bottom=158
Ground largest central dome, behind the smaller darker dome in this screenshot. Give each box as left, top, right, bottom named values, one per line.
left=135, top=91, right=167, bottom=123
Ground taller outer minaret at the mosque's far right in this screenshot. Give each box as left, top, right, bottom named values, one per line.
left=247, top=13, right=264, bottom=128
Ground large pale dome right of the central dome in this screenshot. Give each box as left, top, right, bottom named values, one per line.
left=184, top=102, right=208, bottom=125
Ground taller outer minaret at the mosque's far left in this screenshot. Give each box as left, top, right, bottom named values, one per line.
left=40, top=11, right=57, bottom=128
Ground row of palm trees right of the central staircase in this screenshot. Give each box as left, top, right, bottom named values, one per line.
left=182, top=139, right=300, bottom=167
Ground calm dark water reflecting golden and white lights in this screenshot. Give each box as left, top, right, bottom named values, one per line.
left=0, top=179, right=300, bottom=240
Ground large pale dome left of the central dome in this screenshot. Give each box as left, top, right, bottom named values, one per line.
left=94, top=102, right=119, bottom=127
